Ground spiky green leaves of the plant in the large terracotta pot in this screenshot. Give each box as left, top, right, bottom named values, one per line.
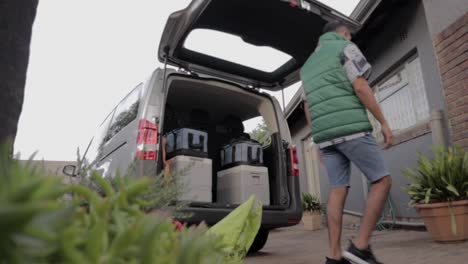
left=403, top=147, right=468, bottom=204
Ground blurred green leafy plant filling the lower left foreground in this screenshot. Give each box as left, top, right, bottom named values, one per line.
left=0, top=144, right=225, bottom=264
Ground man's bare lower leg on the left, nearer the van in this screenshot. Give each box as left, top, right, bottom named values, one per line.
left=327, top=187, right=348, bottom=260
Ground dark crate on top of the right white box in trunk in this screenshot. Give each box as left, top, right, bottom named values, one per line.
left=221, top=139, right=263, bottom=168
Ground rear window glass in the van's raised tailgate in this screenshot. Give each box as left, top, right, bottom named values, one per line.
left=184, top=29, right=292, bottom=72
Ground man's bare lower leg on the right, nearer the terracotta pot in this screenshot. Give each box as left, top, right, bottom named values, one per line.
left=353, top=176, right=392, bottom=249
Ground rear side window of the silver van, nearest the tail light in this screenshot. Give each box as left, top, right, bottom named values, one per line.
left=104, top=84, right=143, bottom=142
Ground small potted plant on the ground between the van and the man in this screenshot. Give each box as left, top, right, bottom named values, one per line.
left=302, top=193, right=322, bottom=230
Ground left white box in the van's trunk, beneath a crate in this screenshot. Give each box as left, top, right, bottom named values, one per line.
left=170, top=156, right=212, bottom=203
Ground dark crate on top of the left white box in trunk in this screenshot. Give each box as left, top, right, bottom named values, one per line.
left=166, top=128, right=208, bottom=159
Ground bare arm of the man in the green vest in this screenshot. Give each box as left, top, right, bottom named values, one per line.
left=353, top=77, right=393, bottom=149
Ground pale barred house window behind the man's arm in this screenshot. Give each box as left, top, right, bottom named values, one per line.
left=373, top=56, right=429, bottom=134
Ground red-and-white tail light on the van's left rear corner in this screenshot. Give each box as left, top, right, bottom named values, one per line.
left=136, top=119, right=158, bottom=160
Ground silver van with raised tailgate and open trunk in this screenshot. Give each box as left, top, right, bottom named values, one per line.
left=66, top=0, right=354, bottom=252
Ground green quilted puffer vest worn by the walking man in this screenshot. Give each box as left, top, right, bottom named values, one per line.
left=301, top=32, right=372, bottom=144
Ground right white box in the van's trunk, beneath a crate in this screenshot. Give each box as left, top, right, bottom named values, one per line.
left=217, top=165, right=270, bottom=205
